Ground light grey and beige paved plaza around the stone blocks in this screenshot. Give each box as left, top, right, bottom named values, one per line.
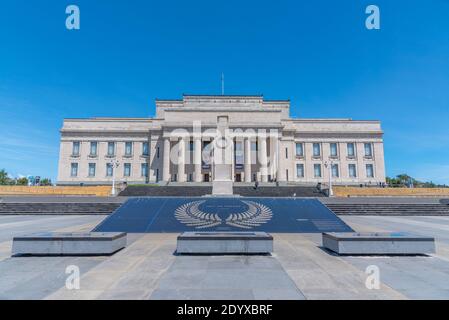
left=0, top=216, right=449, bottom=300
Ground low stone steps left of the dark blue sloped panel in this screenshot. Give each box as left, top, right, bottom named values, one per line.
left=0, top=202, right=121, bottom=215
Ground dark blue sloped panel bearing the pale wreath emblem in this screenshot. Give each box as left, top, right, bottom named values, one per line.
left=94, top=198, right=353, bottom=233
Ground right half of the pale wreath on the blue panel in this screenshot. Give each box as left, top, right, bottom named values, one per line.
left=226, top=201, right=273, bottom=229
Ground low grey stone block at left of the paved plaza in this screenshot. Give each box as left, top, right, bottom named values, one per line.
left=12, top=232, right=126, bottom=256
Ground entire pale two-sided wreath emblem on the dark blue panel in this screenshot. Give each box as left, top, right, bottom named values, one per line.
left=175, top=201, right=273, bottom=229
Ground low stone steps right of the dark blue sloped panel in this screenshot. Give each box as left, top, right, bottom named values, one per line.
left=325, top=202, right=449, bottom=216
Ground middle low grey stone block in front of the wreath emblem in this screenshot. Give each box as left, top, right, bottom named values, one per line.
left=176, top=232, right=273, bottom=254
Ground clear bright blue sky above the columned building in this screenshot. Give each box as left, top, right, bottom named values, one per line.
left=0, top=0, right=449, bottom=183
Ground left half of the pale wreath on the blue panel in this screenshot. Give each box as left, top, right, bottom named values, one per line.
left=175, top=201, right=222, bottom=229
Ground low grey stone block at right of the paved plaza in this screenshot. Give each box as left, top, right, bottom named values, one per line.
left=323, top=232, right=435, bottom=255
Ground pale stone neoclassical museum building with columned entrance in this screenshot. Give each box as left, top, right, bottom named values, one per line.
left=58, top=95, right=385, bottom=185
